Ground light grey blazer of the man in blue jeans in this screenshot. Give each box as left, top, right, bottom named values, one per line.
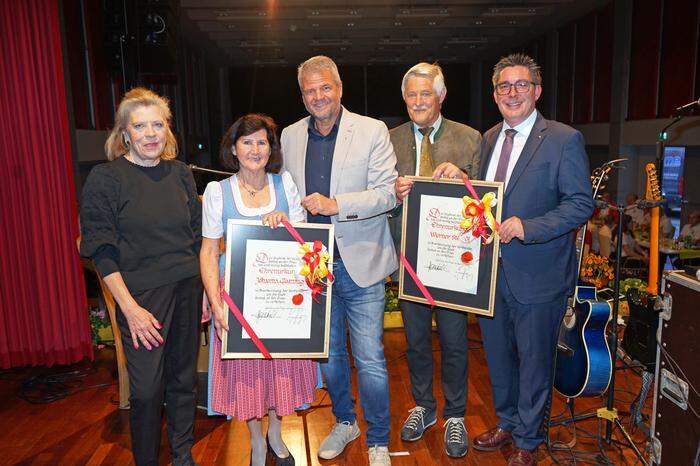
left=281, top=108, right=398, bottom=288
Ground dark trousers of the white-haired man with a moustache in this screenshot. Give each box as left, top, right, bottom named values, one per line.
left=401, top=301, right=468, bottom=419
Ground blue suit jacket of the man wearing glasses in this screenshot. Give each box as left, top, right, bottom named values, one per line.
left=480, top=113, right=593, bottom=304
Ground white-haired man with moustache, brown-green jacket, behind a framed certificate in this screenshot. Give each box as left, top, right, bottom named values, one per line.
left=390, top=63, right=481, bottom=458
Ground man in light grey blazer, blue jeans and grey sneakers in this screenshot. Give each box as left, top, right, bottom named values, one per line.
left=281, top=56, right=397, bottom=466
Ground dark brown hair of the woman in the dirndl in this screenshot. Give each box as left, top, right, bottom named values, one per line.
left=219, top=113, right=282, bottom=173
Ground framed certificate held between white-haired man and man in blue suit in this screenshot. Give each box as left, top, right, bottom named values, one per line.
left=399, top=176, right=503, bottom=316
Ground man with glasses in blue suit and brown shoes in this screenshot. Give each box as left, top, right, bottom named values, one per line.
left=474, top=54, right=593, bottom=466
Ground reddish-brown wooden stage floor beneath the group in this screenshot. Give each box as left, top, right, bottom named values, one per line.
left=0, top=325, right=651, bottom=466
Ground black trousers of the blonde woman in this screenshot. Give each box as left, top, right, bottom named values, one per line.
left=117, top=276, right=202, bottom=466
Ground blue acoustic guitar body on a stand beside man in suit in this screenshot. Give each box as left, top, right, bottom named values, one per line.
left=554, top=286, right=612, bottom=398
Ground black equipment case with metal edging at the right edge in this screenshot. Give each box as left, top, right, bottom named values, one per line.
left=650, top=271, right=700, bottom=466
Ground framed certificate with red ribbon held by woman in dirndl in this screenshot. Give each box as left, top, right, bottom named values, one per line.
left=221, top=219, right=334, bottom=359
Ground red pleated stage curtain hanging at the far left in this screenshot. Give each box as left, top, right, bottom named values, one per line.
left=0, top=0, right=92, bottom=368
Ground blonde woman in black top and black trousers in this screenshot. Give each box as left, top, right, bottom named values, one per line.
left=80, top=88, right=202, bottom=466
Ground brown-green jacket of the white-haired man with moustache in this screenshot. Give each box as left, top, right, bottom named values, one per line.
left=389, top=117, right=481, bottom=178
